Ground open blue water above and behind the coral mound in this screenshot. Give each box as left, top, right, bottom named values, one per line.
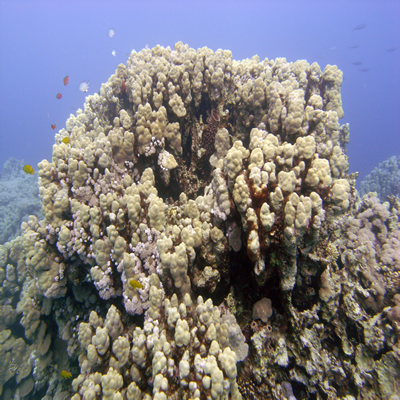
left=0, top=0, right=400, bottom=184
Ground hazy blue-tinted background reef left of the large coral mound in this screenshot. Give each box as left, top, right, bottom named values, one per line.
left=0, top=158, right=42, bottom=244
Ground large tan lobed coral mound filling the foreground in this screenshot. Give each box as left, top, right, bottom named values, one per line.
left=0, top=43, right=400, bottom=400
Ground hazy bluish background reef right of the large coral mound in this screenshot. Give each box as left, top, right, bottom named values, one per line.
left=360, top=156, right=400, bottom=201
